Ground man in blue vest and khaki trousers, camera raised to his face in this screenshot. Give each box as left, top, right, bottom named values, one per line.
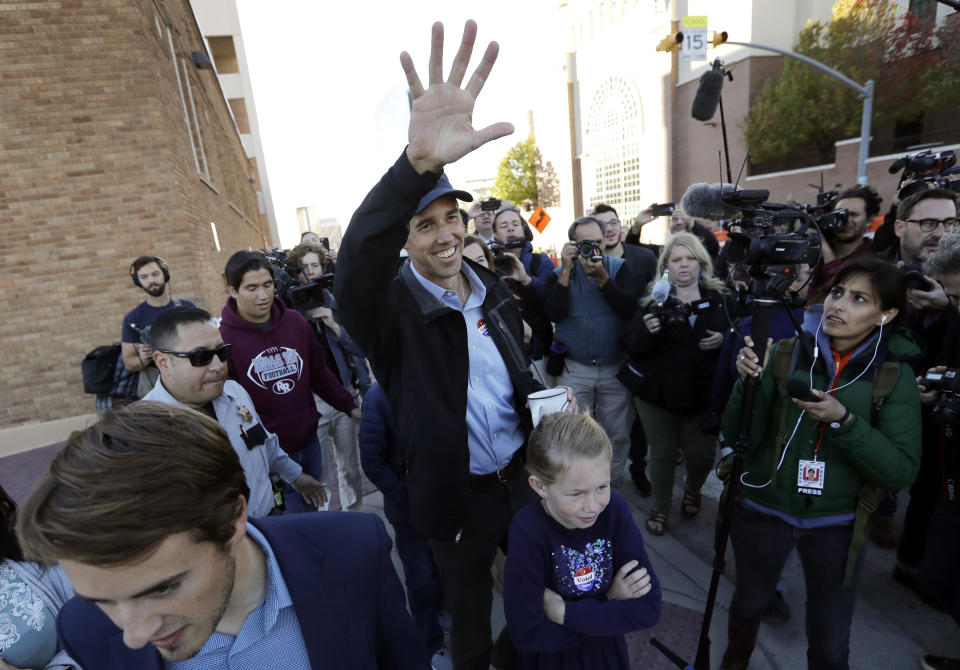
left=544, top=216, right=638, bottom=485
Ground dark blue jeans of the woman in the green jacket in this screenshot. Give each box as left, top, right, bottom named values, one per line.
left=730, top=502, right=866, bottom=670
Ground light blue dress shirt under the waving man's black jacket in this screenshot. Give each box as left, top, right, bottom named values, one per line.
left=410, top=263, right=524, bottom=475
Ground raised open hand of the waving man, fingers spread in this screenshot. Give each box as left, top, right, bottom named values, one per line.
left=400, top=21, right=513, bottom=174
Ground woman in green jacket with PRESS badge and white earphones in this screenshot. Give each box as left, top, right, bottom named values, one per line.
left=721, top=256, right=920, bottom=670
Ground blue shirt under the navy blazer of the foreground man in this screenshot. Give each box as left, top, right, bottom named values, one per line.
left=164, top=524, right=311, bottom=670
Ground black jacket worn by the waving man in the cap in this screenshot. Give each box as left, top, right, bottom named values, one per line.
left=334, top=154, right=542, bottom=539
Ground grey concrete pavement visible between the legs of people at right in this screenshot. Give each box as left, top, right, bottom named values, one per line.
left=361, top=468, right=960, bottom=670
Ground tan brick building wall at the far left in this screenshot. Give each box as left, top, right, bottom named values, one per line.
left=0, top=0, right=269, bottom=436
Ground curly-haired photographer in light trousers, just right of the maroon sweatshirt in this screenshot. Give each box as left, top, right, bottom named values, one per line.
left=288, top=243, right=370, bottom=510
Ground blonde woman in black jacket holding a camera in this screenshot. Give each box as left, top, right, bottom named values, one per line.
left=619, top=232, right=728, bottom=535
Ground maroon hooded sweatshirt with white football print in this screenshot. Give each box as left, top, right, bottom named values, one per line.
left=220, top=298, right=356, bottom=453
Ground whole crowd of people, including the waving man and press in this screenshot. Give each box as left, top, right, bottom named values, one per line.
left=0, top=17, right=960, bottom=670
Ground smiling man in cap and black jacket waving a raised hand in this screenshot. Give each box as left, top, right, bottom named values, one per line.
left=334, top=21, right=540, bottom=670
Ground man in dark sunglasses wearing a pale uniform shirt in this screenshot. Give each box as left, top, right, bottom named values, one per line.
left=143, top=307, right=325, bottom=517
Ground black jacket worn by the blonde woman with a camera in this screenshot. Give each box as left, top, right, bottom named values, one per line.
left=619, top=286, right=729, bottom=416
